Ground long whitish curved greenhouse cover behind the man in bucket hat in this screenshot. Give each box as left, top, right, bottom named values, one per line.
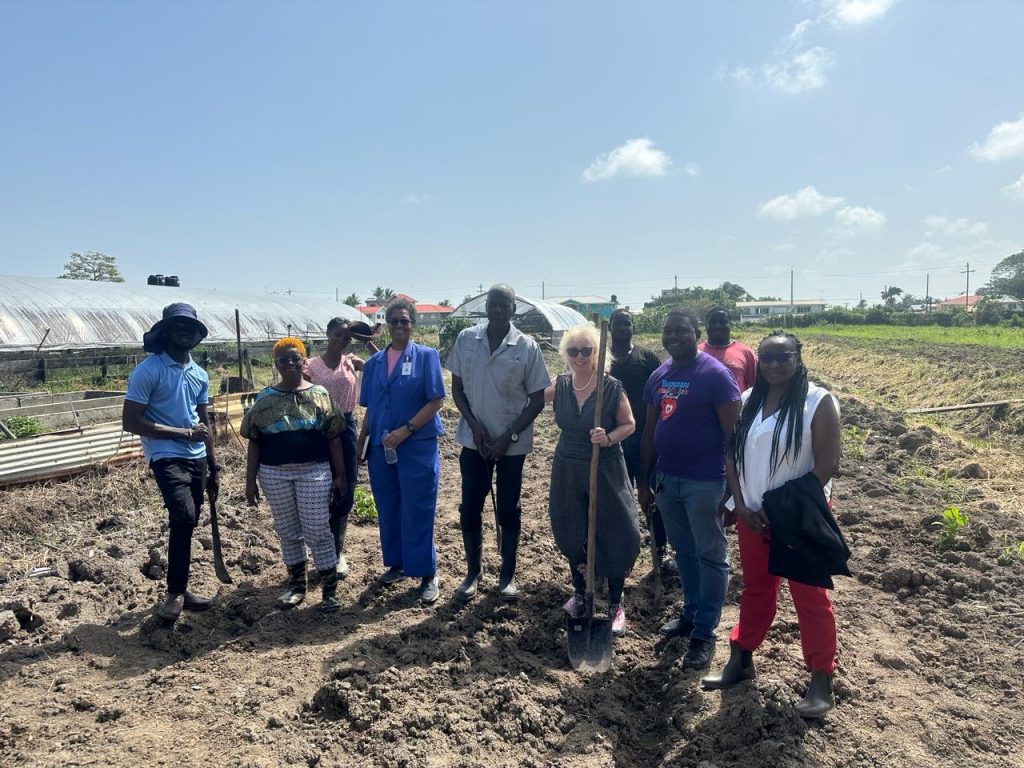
left=0, top=275, right=365, bottom=349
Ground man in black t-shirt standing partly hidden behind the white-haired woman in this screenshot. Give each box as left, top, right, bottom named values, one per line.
left=608, top=309, right=675, bottom=567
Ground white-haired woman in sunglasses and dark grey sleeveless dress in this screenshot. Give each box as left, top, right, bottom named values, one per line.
left=544, top=325, right=640, bottom=635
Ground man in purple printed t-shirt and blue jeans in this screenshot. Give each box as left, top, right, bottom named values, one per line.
left=639, top=309, right=739, bottom=670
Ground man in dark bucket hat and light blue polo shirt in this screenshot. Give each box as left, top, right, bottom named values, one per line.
left=122, top=303, right=220, bottom=622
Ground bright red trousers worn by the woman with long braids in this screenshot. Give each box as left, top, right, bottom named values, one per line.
left=729, top=520, right=836, bottom=673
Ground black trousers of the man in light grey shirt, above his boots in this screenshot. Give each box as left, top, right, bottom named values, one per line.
left=459, top=447, right=526, bottom=536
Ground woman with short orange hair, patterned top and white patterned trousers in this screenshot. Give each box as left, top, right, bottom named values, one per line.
left=241, top=337, right=346, bottom=611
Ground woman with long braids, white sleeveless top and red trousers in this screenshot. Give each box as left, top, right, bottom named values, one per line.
left=702, top=331, right=840, bottom=718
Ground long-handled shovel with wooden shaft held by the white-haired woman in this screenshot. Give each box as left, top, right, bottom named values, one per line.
left=565, top=321, right=611, bottom=672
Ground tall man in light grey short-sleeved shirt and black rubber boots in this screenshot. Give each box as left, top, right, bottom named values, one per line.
left=445, top=283, right=551, bottom=601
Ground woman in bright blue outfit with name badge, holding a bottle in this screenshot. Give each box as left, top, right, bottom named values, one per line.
left=358, top=299, right=444, bottom=603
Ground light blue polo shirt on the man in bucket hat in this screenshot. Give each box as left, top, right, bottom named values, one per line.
left=125, top=352, right=210, bottom=461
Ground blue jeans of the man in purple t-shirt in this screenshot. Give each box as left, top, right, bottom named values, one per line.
left=654, top=472, right=729, bottom=640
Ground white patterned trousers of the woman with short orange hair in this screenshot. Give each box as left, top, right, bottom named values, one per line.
left=259, top=462, right=338, bottom=570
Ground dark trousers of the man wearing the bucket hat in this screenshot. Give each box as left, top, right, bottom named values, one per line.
left=150, top=459, right=207, bottom=595
